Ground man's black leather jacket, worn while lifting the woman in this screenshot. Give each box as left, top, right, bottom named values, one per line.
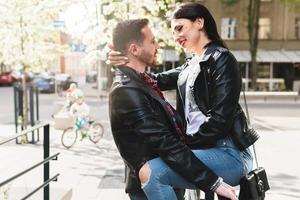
left=109, top=67, right=218, bottom=192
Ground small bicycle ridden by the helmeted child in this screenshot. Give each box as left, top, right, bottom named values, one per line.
left=61, top=118, right=104, bottom=149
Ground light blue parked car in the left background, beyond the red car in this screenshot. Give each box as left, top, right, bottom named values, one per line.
left=32, top=76, right=55, bottom=93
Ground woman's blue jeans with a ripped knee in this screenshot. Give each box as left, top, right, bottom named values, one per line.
left=142, top=138, right=253, bottom=200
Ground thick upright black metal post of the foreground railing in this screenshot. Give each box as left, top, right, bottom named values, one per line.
left=44, top=124, right=50, bottom=200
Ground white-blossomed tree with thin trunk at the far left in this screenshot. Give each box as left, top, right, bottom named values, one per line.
left=0, top=0, right=78, bottom=128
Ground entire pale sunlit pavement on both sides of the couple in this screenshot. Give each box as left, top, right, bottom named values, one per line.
left=0, top=117, right=300, bottom=200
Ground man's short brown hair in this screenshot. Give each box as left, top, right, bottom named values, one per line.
left=113, top=19, right=149, bottom=54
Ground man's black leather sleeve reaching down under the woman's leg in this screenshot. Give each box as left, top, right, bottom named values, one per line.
left=111, top=88, right=219, bottom=191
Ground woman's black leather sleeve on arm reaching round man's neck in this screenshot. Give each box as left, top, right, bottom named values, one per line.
left=153, top=65, right=184, bottom=91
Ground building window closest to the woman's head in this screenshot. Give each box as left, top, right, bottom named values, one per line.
left=221, top=17, right=236, bottom=40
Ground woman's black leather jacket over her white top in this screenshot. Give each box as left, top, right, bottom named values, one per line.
left=154, top=43, right=253, bottom=150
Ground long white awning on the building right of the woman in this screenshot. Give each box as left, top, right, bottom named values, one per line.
left=231, top=50, right=300, bottom=63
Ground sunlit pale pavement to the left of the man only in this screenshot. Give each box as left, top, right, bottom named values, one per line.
left=0, top=124, right=128, bottom=200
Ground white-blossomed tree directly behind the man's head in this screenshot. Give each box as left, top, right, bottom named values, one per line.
left=81, top=0, right=181, bottom=65
